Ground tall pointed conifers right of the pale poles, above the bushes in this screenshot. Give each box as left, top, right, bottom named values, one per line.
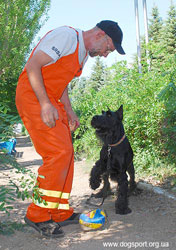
left=141, top=1, right=176, bottom=71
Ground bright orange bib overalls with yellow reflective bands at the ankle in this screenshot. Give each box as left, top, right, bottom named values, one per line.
left=16, top=29, right=82, bottom=223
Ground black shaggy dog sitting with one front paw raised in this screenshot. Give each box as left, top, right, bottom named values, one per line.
left=89, top=106, right=136, bottom=214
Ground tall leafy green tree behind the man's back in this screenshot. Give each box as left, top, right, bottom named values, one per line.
left=0, top=0, right=50, bottom=113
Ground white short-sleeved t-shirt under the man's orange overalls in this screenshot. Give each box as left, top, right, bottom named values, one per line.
left=34, top=26, right=88, bottom=69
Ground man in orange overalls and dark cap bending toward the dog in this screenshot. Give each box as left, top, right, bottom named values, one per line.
left=16, top=21, right=125, bottom=237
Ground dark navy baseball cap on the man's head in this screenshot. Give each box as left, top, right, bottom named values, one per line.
left=96, top=20, right=125, bottom=55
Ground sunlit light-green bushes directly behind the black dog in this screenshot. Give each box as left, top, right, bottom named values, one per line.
left=72, top=57, right=176, bottom=180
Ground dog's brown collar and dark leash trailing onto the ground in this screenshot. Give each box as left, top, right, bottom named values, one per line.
left=86, top=134, right=126, bottom=207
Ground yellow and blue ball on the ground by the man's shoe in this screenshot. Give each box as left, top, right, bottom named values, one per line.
left=79, top=209, right=107, bottom=231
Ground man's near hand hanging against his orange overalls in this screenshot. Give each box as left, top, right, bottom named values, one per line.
left=41, top=103, right=59, bottom=128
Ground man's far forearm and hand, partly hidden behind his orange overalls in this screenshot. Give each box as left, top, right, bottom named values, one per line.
left=60, top=87, right=80, bottom=131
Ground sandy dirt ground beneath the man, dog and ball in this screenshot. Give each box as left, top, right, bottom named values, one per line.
left=0, top=139, right=176, bottom=250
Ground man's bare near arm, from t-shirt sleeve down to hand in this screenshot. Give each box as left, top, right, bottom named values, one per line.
left=26, top=50, right=59, bottom=128
